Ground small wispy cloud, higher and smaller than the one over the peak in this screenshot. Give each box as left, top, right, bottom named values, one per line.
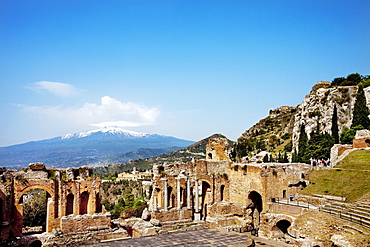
left=30, top=81, right=78, bottom=98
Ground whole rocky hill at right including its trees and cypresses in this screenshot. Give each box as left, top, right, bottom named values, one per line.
left=231, top=73, right=370, bottom=163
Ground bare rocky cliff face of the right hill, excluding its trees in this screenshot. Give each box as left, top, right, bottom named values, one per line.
left=232, top=78, right=370, bottom=158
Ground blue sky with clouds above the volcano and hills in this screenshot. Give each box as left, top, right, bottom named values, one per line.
left=0, top=0, right=370, bottom=146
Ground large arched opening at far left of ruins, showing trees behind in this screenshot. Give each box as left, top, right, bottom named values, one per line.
left=19, top=188, right=51, bottom=235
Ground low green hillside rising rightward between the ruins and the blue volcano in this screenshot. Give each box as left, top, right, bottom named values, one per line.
left=94, top=134, right=234, bottom=177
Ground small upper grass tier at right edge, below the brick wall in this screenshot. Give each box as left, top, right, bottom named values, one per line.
left=335, top=150, right=370, bottom=170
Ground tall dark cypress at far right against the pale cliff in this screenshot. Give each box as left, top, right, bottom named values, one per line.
left=351, top=86, right=370, bottom=129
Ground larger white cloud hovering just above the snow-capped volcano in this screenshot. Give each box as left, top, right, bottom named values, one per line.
left=21, top=96, right=161, bottom=127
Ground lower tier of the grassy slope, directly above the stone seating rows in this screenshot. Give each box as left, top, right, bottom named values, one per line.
left=300, top=168, right=370, bottom=202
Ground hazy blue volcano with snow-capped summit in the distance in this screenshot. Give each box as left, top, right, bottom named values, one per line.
left=0, top=128, right=194, bottom=169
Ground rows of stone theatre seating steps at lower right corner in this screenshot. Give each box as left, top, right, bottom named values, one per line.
left=319, top=195, right=370, bottom=228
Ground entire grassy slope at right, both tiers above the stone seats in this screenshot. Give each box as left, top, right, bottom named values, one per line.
left=301, top=150, right=370, bottom=202
